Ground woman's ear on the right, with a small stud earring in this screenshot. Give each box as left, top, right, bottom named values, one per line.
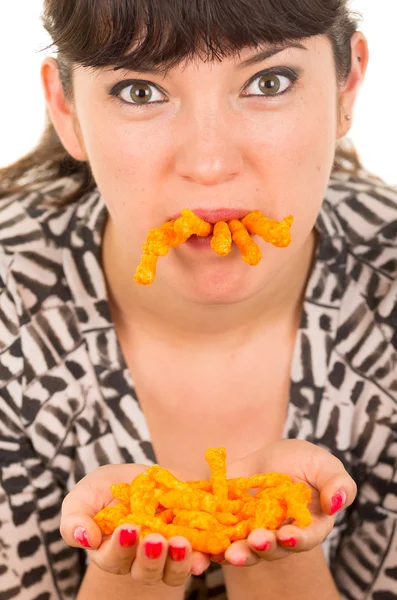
left=337, top=31, right=369, bottom=139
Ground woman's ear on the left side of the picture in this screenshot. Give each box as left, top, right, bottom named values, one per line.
left=41, top=57, right=88, bottom=161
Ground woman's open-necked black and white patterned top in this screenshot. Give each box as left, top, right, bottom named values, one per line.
left=0, top=173, right=397, bottom=600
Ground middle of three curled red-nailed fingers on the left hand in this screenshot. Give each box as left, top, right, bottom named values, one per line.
left=131, top=533, right=168, bottom=584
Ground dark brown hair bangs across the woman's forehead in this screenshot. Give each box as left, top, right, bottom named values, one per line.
left=46, top=0, right=342, bottom=73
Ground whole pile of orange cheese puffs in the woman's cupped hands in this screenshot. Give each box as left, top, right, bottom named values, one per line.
left=94, top=448, right=312, bottom=554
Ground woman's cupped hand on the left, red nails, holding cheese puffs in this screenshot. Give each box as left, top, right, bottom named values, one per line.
left=60, top=465, right=209, bottom=586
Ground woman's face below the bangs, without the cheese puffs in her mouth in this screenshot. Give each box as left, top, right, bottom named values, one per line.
left=69, top=36, right=344, bottom=303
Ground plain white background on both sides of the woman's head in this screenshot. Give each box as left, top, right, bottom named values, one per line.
left=0, top=0, right=397, bottom=185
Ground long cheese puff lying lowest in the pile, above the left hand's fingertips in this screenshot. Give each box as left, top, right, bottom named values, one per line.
left=120, top=515, right=231, bottom=554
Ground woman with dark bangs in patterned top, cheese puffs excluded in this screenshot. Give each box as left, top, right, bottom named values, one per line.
left=0, top=0, right=397, bottom=600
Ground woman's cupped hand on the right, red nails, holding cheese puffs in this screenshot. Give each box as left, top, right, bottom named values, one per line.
left=218, top=439, right=357, bottom=566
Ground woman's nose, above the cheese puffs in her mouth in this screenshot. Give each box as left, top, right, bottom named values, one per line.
left=175, top=108, right=243, bottom=185
